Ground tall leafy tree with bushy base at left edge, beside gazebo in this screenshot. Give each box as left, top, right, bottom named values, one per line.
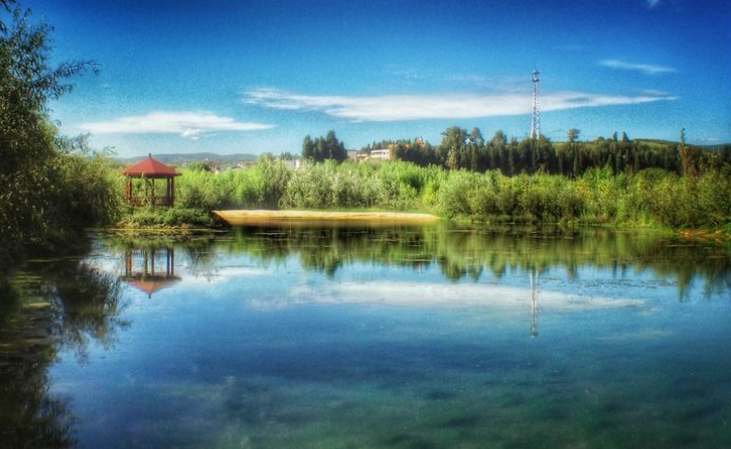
left=0, top=6, right=111, bottom=264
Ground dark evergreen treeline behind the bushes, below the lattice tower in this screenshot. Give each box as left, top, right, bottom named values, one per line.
left=352, top=126, right=731, bottom=178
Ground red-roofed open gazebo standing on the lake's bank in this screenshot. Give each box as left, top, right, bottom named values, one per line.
left=122, top=154, right=180, bottom=206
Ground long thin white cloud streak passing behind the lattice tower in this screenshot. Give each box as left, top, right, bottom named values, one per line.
left=244, top=89, right=677, bottom=122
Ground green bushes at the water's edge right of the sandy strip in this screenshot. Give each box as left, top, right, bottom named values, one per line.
left=439, top=164, right=731, bottom=228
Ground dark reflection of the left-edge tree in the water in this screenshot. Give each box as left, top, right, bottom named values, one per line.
left=0, top=259, right=128, bottom=448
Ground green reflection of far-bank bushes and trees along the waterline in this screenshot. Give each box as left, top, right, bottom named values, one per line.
left=222, top=225, right=731, bottom=299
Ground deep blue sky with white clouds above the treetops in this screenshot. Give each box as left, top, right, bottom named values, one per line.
left=21, top=0, right=731, bottom=157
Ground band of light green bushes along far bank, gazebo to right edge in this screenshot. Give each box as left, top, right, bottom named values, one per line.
left=169, top=161, right=731, bottom=231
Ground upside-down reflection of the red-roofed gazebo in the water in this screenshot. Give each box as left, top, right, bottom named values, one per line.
left=121, top=247, right=180, bottom=298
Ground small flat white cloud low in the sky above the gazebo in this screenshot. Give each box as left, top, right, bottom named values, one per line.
left=79, top=111, right=274, bottom=138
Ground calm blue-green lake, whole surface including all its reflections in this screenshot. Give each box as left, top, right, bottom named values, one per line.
left=0, top=225, right=731, bottom=449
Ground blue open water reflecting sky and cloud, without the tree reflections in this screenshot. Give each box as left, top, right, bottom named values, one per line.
left=47, top=229, right=731, bottom=448
